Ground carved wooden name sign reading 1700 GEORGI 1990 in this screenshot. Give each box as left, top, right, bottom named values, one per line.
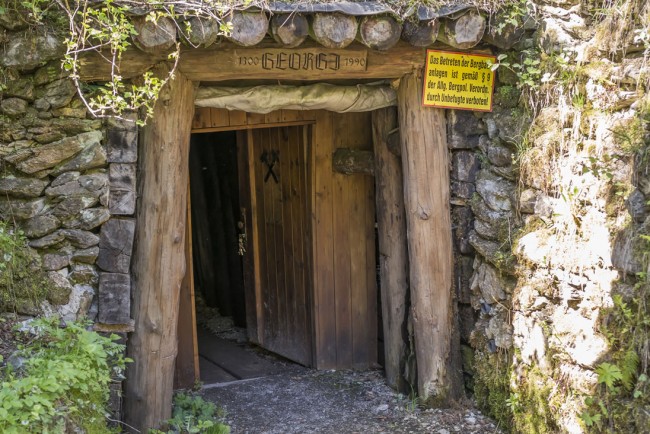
left=233, top=48, right=368, bottom=72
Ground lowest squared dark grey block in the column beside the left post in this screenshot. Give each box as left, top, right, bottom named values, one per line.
left=98, top=273, right=131, bottom=324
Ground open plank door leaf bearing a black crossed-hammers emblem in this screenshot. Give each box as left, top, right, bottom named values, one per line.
left=248, top=126, right=312, bottom=366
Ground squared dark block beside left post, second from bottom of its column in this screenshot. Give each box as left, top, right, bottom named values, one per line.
left=97, top=218, right=135, bottom=273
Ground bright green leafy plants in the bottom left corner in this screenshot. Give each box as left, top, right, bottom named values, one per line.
left=0, top=317, right=128, bottom=434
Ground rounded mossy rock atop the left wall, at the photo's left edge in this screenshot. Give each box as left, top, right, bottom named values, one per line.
left=0, top=30, right=65, bottom=71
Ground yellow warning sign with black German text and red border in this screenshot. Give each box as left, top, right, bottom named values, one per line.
left=422, top=50, right=496, bottom=112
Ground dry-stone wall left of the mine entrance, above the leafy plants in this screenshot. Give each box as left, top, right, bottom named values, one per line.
left=0, top=28, right=137, bottom=332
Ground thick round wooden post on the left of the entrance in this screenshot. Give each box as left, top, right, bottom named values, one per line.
left=124, top=72, right=194, bottom=432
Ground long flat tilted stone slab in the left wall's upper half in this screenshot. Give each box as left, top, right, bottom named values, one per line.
left=16, top=131, right=102, bottom=173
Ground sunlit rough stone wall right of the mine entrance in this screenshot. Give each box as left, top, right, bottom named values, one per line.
left=448, top=1, right=650, bottom=433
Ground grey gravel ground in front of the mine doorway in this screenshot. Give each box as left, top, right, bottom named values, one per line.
left=202, top=361, right=502, bottom=434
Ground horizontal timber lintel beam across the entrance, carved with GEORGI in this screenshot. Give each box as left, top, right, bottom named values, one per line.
left=80, top=40, right=425, bottom=82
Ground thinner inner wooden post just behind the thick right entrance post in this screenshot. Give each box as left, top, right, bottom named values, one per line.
left=372, top=107, right=408, bottom=392
